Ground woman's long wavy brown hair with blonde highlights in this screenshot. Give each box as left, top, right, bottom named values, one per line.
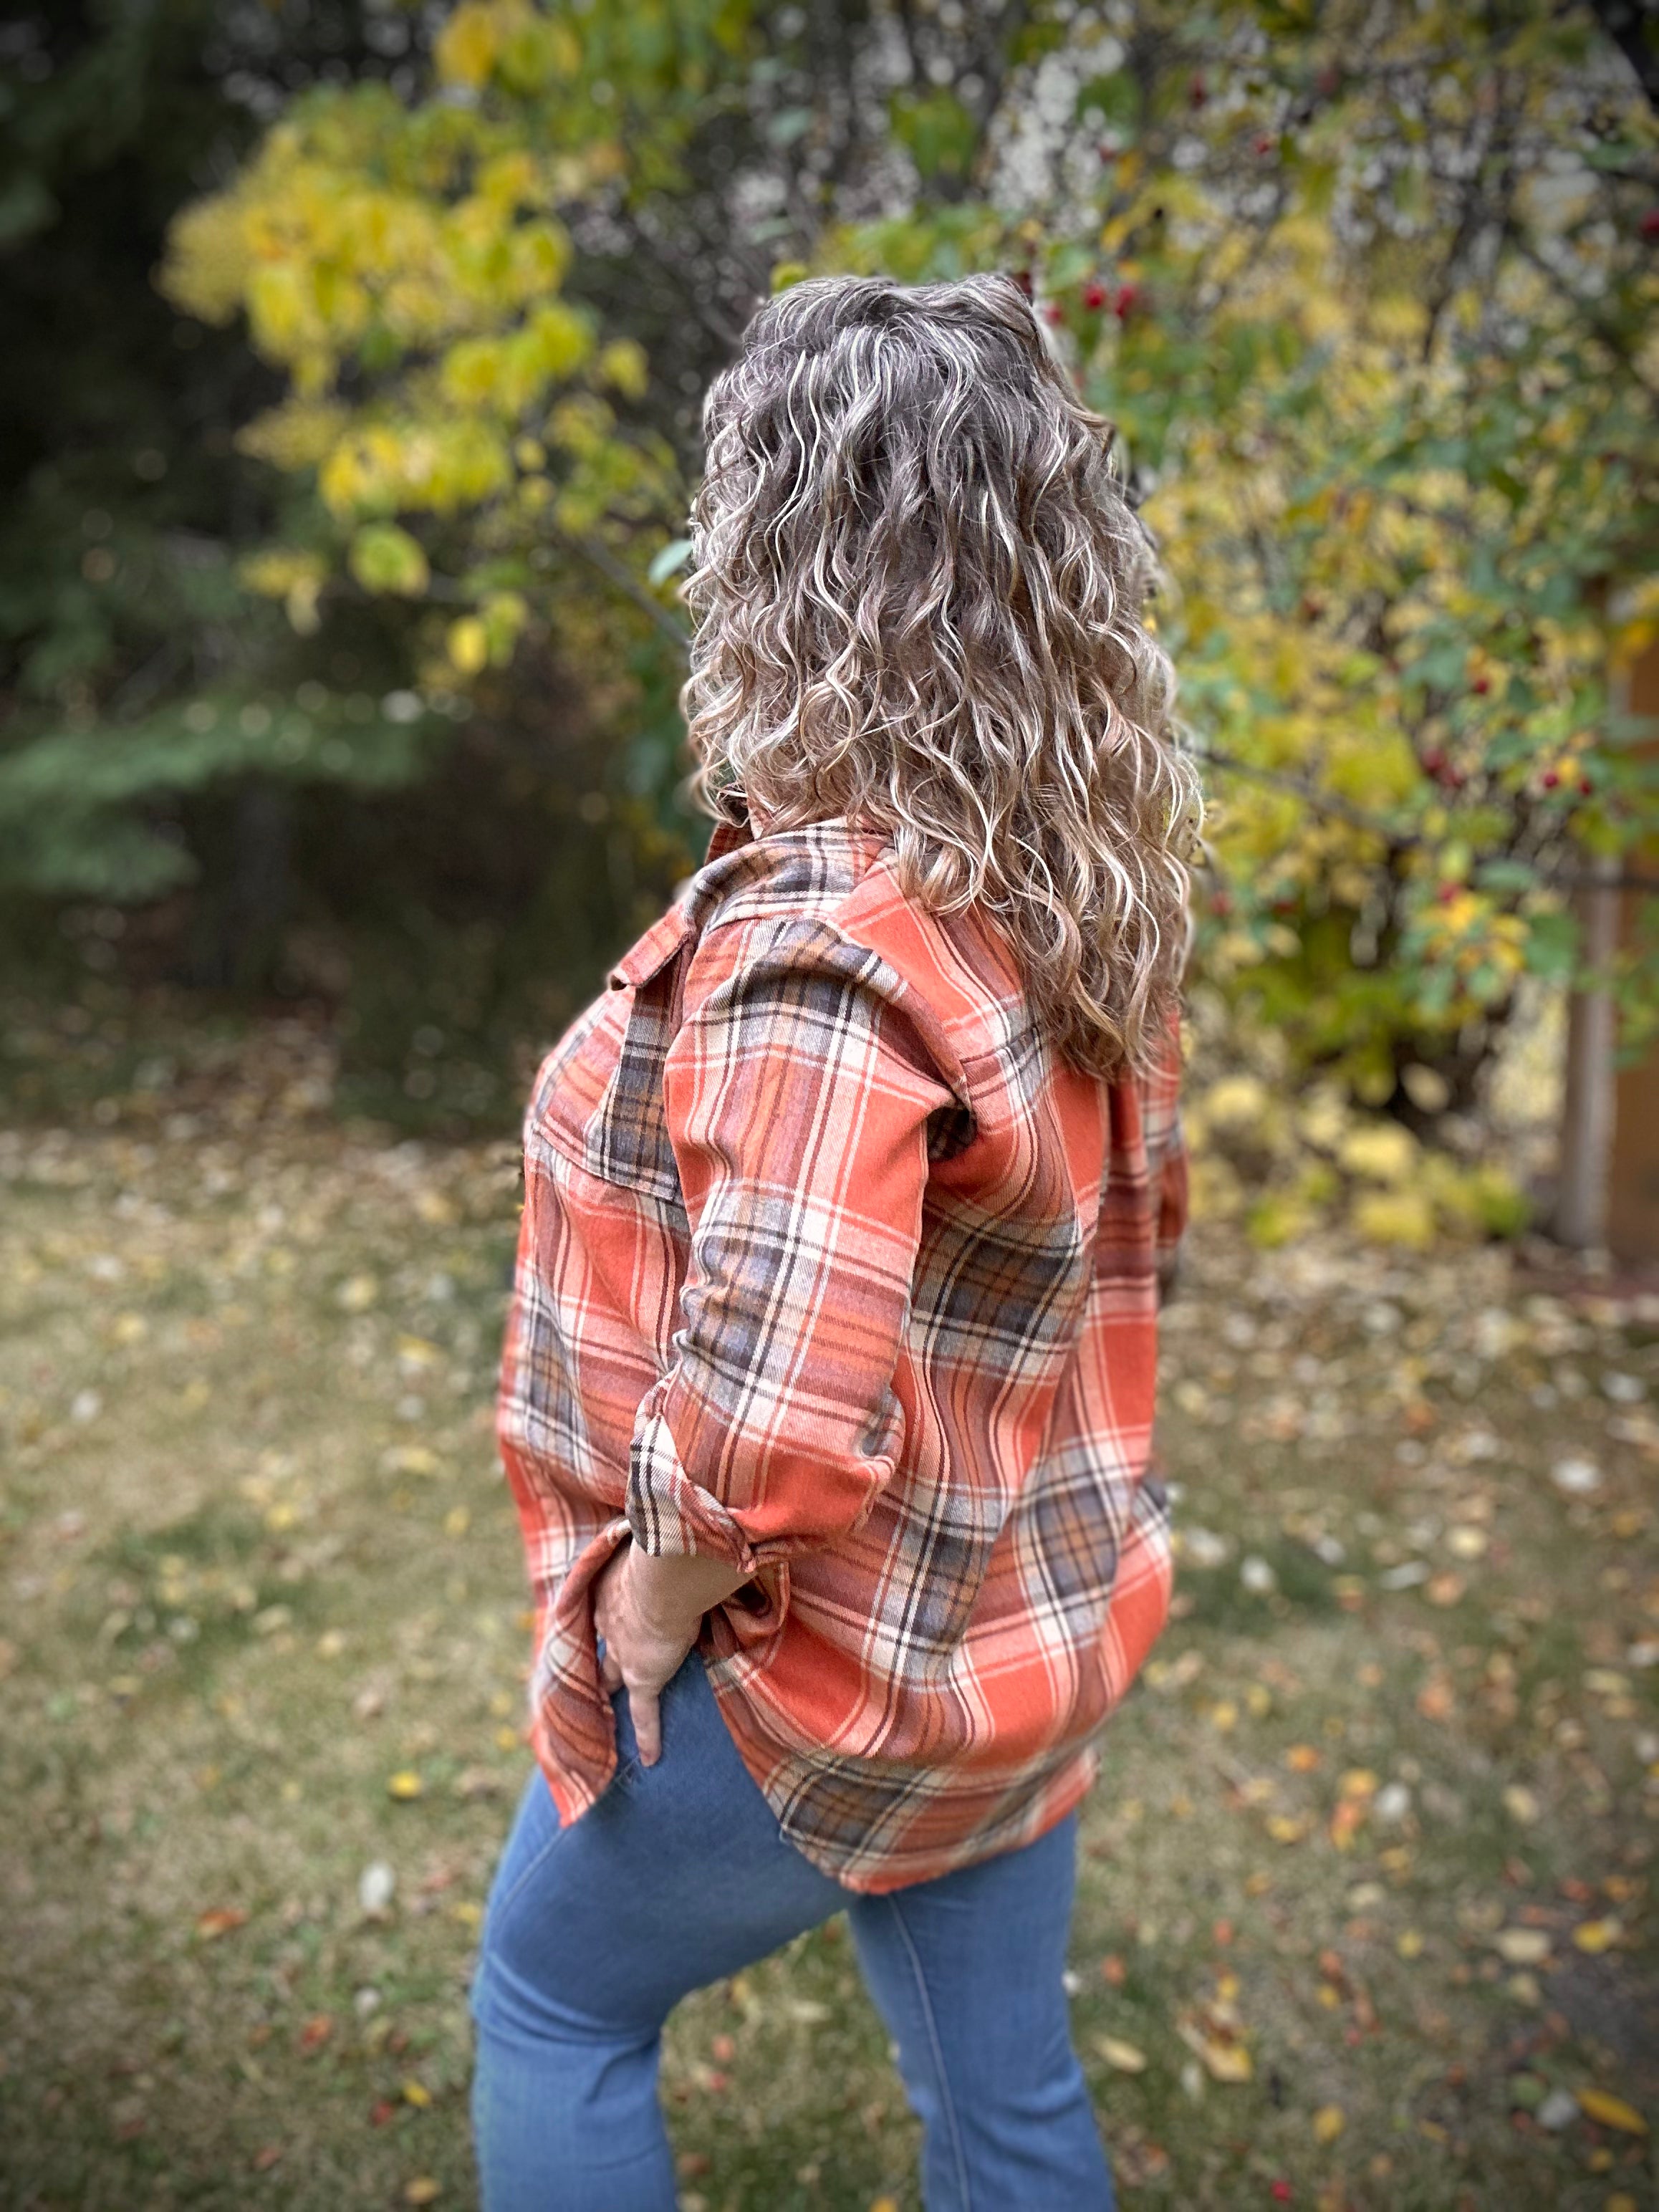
left=683, top=276, right=1199, bottom=1075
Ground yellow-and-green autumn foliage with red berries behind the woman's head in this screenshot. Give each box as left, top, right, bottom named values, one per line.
left=16, top=0, right=1659, bottom=1176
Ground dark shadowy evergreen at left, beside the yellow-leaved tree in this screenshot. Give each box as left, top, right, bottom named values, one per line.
left=0, top=0, right=686, bottom=1124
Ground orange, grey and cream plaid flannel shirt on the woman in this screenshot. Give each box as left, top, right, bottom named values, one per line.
left=498, top=819, right=1186, bottom=1891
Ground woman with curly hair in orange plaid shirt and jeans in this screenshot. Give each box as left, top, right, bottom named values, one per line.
left=473, top=276, right=1197, bottom=2212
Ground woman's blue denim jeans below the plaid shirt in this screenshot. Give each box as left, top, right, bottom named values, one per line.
left=471, top=1653, right=1112, bottom=2212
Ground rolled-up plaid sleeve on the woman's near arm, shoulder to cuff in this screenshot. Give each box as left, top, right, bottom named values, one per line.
left=628, top=920, right=960, bottom=1573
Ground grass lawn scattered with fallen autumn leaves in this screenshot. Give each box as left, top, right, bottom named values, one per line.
left=0, top=1026, right=1659, bottom=2212
